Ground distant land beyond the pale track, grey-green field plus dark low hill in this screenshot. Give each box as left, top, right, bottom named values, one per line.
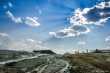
left=0, top=50, right=56, bottom=62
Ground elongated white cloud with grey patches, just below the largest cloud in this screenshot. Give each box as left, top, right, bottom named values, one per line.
left=49, top=25, right=90, bottom=38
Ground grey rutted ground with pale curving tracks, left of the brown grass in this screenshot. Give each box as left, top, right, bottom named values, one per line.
left=0, top=49, right=70, bottom=73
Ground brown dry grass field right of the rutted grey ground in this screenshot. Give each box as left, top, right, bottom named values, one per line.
left=66, top=53, right=110, bottom=73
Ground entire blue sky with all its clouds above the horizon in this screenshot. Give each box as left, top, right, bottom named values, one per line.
left=0, top=0, right=110, bottom=53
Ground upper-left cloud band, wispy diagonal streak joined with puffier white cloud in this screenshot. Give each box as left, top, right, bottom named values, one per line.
left=6, top=11, right=40, bottom=27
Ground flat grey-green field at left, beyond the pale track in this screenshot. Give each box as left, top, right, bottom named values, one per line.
left=0, top=50, right=34, bottom=61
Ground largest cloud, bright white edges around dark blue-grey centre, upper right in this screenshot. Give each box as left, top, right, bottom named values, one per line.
left=70, top=1, right=110, bottom=25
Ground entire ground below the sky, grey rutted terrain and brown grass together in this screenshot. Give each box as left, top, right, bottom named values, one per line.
left=0, top=50, right=110, bottom=73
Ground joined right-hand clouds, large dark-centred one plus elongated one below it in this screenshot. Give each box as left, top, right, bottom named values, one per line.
left=49, top=1, right=110, bottom=38
